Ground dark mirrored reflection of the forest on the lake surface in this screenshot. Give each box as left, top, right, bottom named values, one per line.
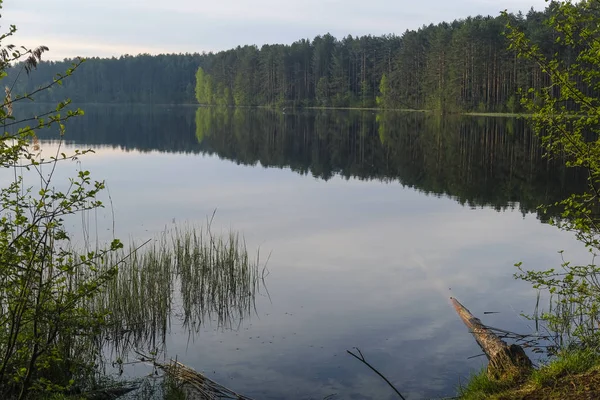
left=36, top=106, right=584, bottom=216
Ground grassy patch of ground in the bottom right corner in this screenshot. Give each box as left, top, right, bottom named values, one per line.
left=458, top=350, right=600, bottom=400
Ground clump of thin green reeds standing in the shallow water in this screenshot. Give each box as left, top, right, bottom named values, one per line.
left=90, top=224, right=263, bottom=353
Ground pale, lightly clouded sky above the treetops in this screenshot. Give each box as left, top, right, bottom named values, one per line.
left=0, top=0, right=546, bottom=60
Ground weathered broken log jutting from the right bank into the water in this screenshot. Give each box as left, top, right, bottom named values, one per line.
left=450, top=297, right=533, bottom=380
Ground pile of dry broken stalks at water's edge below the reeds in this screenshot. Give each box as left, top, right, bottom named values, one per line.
left=154, top=360, right=252, bottom=400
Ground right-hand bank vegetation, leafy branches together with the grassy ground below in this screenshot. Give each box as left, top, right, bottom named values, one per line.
left=461, top=1, right=600, bottom=399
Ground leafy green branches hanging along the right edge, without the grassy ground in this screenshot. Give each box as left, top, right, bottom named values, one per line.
left=505, top=1, right=600, bottom=348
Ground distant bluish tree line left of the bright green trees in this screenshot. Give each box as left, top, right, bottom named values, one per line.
left=6, top=54, right=204, bottom=104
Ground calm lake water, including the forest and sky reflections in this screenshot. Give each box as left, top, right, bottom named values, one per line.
left=31, top=106, right=585, bottom=399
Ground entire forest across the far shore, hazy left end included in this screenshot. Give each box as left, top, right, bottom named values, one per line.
left=4, top=3, right=575, bottom=112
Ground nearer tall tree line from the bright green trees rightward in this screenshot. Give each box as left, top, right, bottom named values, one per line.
left=196, top=3, right=572, bottom=112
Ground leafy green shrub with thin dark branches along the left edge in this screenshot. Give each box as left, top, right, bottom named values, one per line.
left=0, top=2, right=121, bottom=399
